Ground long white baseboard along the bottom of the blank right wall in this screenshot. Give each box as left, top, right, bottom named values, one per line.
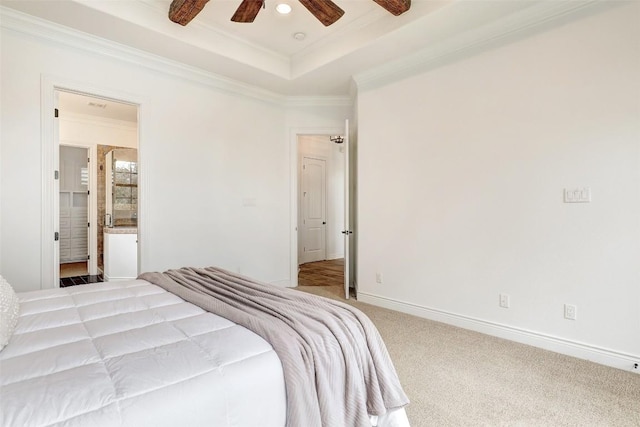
left=358, top=292, right=640, bottom=374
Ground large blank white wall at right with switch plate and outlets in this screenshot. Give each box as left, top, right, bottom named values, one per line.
left=358, top=2, right=640, bottom=369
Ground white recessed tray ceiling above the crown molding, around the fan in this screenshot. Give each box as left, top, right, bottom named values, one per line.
left=0, top=0, right=559, bottom=96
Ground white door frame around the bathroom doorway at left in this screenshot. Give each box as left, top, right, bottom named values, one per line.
left=40, top=75, right=149, bottom=289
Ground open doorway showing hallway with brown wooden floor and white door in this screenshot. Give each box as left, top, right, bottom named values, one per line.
left=297, top=134, right=346, bottom=297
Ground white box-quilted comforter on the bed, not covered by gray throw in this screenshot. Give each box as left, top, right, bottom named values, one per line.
left=0, top=270, right=409, bottom=427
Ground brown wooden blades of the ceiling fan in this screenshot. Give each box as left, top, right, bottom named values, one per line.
left=169, top=0, right=411, bottom=27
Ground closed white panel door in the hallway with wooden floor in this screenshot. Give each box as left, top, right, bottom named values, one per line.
left=301, top=157, right=327, bottom=264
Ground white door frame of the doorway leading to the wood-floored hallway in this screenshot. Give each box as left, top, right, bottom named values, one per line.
left=289, top=126, right=344, bottom=288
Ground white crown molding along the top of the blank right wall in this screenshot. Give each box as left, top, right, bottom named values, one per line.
left=354, top=0, right=612, bottom=90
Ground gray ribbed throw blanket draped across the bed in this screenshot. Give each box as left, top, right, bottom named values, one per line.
left=139, top=267, right=409, bottom=427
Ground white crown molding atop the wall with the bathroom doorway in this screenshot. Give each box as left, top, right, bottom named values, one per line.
left=0, top=6, right=344, bottom=107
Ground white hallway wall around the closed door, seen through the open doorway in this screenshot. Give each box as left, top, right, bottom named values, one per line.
left=298, top=135, right=344, bottom=263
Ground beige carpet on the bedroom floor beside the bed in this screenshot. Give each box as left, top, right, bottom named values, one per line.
left=296, top=286, right=640, bottom=427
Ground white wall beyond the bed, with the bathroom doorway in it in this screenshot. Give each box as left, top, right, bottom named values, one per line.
left=0, top=10, right=345, bottom=291
